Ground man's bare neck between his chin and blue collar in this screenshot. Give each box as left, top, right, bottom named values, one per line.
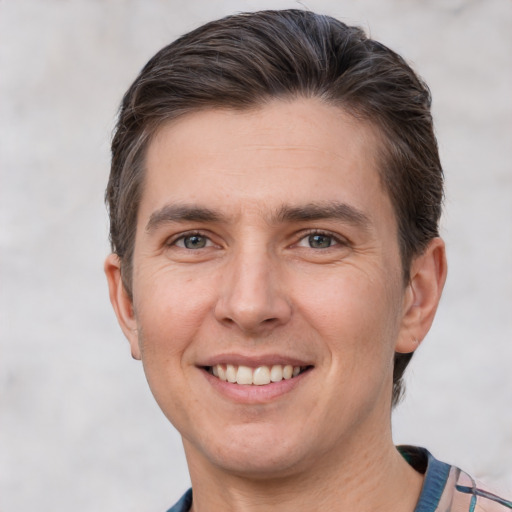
left=184, top=432, right=423, bottom=512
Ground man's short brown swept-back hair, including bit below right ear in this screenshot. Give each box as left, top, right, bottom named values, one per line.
left=106, top=9, right=443, bottom=404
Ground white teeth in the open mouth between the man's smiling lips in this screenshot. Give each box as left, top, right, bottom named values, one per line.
left=204, top=364, right=312, bottom=386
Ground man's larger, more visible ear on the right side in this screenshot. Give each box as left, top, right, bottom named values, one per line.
left=395, top=238, right=447, bottom=354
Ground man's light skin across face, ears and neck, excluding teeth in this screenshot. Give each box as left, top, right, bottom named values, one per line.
left=105, top=99, right=446, bottom=512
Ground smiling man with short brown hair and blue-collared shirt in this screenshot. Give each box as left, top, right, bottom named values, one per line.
left=105, top=10, right=512, bottom=512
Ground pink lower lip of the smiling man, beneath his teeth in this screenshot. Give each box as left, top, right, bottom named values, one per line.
left=201, top=369, right=311, bottom=404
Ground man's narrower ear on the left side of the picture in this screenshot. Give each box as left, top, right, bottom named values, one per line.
left=104, top=254, right=141, bottom=359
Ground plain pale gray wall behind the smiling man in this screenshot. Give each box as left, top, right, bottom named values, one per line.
left=0, top=0, right=512, bottom=512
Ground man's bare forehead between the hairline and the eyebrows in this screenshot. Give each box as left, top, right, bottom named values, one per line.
left=139, top=99, right=389, bottom=227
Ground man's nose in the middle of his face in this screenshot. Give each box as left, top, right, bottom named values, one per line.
left=215, top=248, right=292, bottom=336
